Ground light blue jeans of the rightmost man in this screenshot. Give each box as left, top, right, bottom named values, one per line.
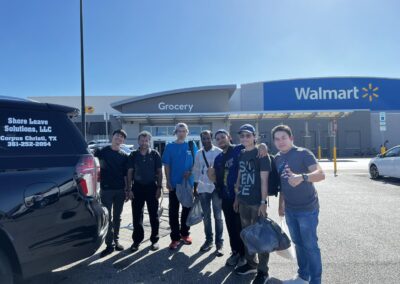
left=285, top=209, right=322, bottom=284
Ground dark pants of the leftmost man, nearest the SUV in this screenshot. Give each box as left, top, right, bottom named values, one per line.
left=101, top=189, right=125, bottom=246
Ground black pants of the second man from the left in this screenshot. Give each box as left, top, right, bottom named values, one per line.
left=132, top=183, right=160, bottom=244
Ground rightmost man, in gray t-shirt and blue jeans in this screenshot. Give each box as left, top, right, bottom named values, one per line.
left=272, top=125, right=325, bottom=284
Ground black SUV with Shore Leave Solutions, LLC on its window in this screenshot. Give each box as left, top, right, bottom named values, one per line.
left=0, top=97, right=108, bottom=283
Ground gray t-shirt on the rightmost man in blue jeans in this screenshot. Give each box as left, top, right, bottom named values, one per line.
left=275, top=146, right=319, bottom=211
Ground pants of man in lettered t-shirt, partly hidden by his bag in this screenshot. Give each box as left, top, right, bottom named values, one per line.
left=239, top=201, right=269, bottom=275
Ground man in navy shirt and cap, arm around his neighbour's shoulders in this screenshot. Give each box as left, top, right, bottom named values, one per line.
left=214, top=129, right=268, bottom=267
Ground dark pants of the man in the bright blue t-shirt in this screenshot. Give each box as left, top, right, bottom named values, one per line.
left=169, top=189, right=190, bottom=241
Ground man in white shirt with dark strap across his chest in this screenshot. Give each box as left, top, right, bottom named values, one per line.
left=193, top=130, right=224, bottom=256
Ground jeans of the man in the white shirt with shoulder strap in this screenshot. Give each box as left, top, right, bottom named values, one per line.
left=199, top=190, right=224, bottom=247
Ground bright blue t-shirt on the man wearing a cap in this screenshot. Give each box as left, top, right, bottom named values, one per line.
left=162, top=142, right=198, bottom=188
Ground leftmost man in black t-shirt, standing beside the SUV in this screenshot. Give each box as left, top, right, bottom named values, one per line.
left=94, top=129, right=128, bottom=257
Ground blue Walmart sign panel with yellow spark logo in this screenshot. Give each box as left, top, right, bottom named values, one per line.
left=264, top=77, right=400, bottom=111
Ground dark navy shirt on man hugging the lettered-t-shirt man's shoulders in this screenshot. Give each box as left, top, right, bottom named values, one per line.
left=214, top=145, right=244, bottom=200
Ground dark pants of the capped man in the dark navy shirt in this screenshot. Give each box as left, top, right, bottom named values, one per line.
left=222, top=199, right=245, bottom=256
